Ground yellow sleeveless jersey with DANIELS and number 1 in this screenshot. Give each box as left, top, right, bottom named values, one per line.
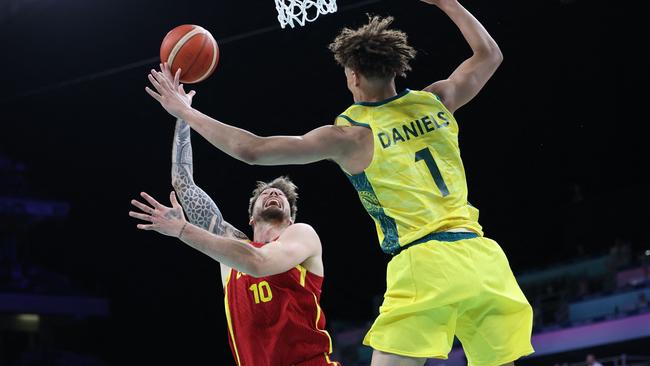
left=335, top=89, right=483, bottom=254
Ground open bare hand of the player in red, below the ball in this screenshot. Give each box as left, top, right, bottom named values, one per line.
left=129, top=191, right=187, bottom=237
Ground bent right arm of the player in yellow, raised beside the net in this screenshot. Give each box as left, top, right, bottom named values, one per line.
left=421, top=0, right=503, bottom=113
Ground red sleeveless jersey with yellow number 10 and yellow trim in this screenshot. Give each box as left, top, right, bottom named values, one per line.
left=224, top=242, right=337, bottom=366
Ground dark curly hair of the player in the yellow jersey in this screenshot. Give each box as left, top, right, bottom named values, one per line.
left=329, top=15, right=416, bottom=79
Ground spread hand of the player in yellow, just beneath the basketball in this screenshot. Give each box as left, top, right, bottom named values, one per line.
left=145, top=64, right=196, bottom=118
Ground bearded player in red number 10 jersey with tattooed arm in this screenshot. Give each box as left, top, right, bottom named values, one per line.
left=129, top=68, right=339, bottom=366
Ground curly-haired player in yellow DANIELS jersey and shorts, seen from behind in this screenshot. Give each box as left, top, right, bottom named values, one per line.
left=147, top=0, right=533, bottom=366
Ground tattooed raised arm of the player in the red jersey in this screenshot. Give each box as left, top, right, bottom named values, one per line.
left=172, top=119, right=248, bottom=240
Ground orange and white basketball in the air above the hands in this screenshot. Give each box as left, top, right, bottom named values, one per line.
left=160, top=24, right=219, bottom=84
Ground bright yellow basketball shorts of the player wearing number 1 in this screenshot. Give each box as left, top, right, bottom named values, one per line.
left=363, top=237, right=534, bottom=366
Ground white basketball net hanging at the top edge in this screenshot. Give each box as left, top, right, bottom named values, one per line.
left=275, top=0, right=336, bottom=28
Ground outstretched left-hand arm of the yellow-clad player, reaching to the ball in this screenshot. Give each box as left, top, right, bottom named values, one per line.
left=146, top=65, right=359, bottom=165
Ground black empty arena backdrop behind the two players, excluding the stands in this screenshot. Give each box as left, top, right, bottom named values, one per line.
left=0, top=0, right=650, bottom=365
